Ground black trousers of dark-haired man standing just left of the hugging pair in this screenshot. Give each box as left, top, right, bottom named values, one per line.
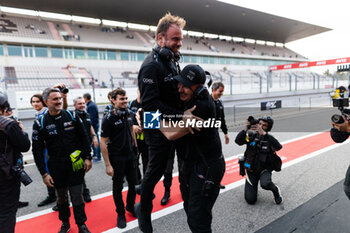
left=111, top=159, right=137, bottom=215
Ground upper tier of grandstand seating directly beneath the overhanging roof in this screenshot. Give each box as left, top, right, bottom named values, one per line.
left=0, top=16, right=302, bottom=58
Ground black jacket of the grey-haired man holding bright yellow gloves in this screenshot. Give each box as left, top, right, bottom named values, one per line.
left=32, top=110, right=91, bottom=175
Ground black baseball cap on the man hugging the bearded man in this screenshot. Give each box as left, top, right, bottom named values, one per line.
left=174, top=65, right=206, bottom=87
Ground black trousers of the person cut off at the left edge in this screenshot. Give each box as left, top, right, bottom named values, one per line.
left=0, top=177, right=20, bottom=233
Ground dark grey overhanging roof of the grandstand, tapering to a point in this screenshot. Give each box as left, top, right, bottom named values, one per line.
left=0, top=0, right=331, bottom=43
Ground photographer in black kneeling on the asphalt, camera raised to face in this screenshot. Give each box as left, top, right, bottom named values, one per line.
left=235, top=116, right=282, bottom=205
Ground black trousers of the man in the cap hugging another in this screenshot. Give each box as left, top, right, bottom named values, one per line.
left=179, top=157, right=225, bottom=233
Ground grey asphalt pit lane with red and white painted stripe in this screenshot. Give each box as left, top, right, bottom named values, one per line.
left=16, top=109, right=350, bottom=232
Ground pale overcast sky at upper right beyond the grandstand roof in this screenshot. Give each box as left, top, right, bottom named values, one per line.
left=220, top=0, right=350, bottom=61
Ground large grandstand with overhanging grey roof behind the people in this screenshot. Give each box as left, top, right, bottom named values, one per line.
left=0, top=0, right=329, bottom=107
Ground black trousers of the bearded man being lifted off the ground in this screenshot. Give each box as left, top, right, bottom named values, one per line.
left=140, top=130, right=173, bottom=215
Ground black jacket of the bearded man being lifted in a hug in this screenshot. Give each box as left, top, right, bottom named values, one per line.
left=138, top=47, right=183, bottom=120
